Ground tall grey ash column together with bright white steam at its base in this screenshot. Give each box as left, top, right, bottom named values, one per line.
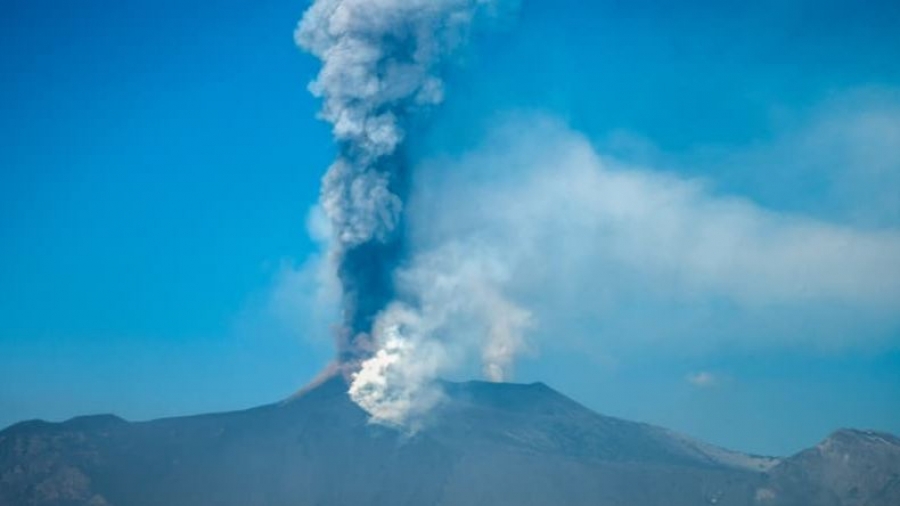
left=295, top=0, right=530, bottom=425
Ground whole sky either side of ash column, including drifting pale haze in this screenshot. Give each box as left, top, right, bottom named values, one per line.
left=0, top=0, right=900, bottom=453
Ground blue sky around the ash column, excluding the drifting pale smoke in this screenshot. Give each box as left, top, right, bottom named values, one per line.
left=0, top=0, right=900, bottom=453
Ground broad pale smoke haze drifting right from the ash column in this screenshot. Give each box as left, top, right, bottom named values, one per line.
left=410, top=117, right=900, bottom=356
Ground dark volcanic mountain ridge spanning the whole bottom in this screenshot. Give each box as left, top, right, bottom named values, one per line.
left=0, top=378, right=900, bottom=506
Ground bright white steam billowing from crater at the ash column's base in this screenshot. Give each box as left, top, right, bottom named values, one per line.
left=350, top=242, right=532, bottom=429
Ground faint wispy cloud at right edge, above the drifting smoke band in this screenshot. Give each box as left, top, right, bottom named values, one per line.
left=644, top=86, right=900, bottom=228
